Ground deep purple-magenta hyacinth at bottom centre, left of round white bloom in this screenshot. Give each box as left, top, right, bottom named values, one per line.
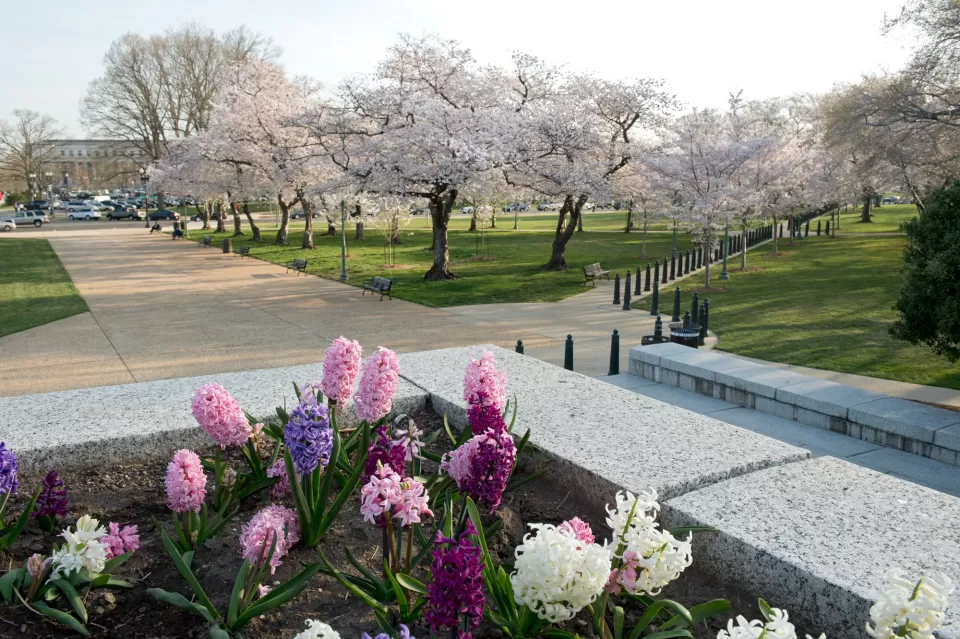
left=423, top=520, right=484, bottom=639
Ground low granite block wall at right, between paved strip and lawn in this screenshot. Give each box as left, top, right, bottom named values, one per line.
left=630, top=344, right=960, bottom=466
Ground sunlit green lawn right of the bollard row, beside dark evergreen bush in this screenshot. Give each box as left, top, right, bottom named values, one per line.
left=643, top=235, right=960, bottom=389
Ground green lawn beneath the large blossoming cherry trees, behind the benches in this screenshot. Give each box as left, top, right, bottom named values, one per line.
left=190, top=228, right=690, bottom=306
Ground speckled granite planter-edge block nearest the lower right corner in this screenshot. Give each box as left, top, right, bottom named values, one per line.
left=662, top=457, right=960, bottom=637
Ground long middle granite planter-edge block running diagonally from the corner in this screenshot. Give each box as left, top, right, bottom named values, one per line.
left=400, top=346, right=809, bottom=503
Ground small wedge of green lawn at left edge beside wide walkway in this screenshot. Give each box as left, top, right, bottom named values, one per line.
left=0, top=239, right=87, bottom=337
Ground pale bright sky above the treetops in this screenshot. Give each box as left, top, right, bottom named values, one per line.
left=0, top=0, right=910, bottom=137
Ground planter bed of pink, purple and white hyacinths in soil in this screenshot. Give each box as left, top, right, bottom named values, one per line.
left=0, top=338, right=952, bottom=639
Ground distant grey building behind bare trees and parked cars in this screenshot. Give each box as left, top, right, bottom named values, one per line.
left=44, top=140, right=150, bottom=190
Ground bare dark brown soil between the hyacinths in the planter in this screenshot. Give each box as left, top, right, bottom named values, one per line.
left=0, top=411, right=760, bottom=639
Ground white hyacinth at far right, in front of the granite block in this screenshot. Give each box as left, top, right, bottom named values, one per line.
left=867, top=568, right=953, bottom=639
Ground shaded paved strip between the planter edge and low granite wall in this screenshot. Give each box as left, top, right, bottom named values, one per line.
left=600, top=375, right=960, bottom=497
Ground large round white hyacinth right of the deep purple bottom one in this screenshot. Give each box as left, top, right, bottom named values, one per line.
left=510, top=524, right=611, bottom=623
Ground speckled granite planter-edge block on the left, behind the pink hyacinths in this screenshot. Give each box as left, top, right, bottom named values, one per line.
left=0, top=364, right=427, bottom=473
